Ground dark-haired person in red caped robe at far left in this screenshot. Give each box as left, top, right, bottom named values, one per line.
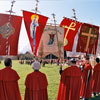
left=0, top=58, right=22, bottom=100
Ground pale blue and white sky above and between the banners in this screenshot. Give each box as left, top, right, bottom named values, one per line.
left=0, top=0, right=100, bottom=53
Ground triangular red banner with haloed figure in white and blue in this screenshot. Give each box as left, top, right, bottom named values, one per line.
left=23, top=11, right=48, bottom=55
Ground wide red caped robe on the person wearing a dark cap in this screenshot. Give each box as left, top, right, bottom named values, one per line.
left=57, top=66, right=81, bottom=100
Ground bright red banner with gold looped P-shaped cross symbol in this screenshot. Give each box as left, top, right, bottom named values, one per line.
left=60, top=18, right=81, bottom=51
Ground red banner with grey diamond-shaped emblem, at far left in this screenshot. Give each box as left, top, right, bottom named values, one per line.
left=0, top=14, right=22, bottom=56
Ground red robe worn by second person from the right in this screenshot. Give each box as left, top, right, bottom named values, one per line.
left=80, top=64, right=93, bottom=98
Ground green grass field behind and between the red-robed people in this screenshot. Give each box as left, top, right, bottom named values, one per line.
left=0, top=60, right=100, bottom=100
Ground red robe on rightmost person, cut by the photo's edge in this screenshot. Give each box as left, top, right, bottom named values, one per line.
left=93, top=64, right=100, bottom=93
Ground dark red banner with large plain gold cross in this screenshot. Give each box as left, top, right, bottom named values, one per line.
left=77, top=23, right=99, bottom=54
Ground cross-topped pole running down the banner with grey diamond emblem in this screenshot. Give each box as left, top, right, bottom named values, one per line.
left=6, top=0, right=16, bottom=56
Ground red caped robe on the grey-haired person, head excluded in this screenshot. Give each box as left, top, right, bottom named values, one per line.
left=24, top=71, right=48, bottom=100
